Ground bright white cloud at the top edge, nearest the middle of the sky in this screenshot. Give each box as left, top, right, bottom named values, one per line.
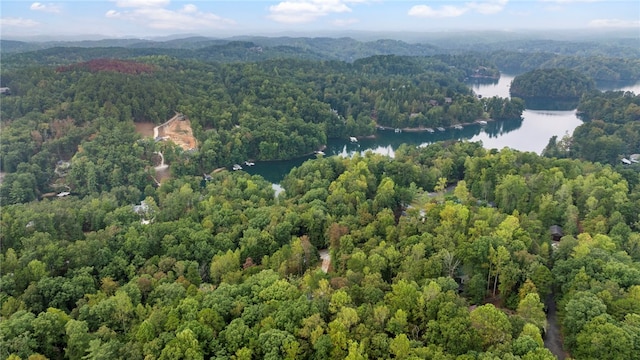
left=268, top=0, right=366, bottom=24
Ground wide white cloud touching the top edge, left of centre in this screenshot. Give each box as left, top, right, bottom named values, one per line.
left=105, top=0, right=235, bottom=30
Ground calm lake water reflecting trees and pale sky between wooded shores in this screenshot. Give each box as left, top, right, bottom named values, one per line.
left=249, top=74, right=640, bottom=184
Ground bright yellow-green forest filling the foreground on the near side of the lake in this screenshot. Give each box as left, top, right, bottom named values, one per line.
left=0, top=143, right=640, bottom=359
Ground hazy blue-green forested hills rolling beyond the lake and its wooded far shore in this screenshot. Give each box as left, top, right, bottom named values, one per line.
left=6, top=32, right=640, bottom=81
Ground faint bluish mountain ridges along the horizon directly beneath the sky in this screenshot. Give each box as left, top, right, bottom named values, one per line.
left=0, top=31, right=640, bottom=62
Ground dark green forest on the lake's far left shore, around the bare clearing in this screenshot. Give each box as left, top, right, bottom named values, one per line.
left=0, top=55, right=524, bottom=204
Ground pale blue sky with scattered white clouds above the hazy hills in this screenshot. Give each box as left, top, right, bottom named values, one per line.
left=0, top=0, right=640, bottom=38
